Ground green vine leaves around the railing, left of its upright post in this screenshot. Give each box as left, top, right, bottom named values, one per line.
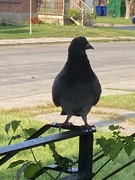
left=5, top=120, right=75, bottom=180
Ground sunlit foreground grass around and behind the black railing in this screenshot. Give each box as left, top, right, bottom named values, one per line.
left=0, top=94, right=135, bottom=180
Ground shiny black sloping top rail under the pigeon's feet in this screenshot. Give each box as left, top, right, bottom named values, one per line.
left=0, top=125, right=95, bottom=156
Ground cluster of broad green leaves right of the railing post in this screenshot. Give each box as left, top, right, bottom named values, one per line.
left=96, top=125, right=135, bottom=161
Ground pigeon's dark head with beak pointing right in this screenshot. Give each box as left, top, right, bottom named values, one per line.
left=69, top=36, right=94, bottom=52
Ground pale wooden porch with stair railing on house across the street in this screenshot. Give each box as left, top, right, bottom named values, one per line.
left=38, top=0, right=93, bottom=26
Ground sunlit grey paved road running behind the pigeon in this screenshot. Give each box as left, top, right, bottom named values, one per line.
left=0, top=42, right=135, bottom=108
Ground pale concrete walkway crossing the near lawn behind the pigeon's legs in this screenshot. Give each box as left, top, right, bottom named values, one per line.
left=36, top=107, right=135, bottom=135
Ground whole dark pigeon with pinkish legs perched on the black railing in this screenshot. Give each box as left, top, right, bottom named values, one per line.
left=52, top=37, right=101, bottom=128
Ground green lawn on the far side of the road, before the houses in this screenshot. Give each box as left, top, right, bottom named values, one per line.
left=0, top=17, right=135, bottom=39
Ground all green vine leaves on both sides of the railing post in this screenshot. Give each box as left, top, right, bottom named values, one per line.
left=2, top=120, right=135, bottom=180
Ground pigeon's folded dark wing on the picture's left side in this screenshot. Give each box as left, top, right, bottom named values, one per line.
left=52, top=73, right=62, bottom=106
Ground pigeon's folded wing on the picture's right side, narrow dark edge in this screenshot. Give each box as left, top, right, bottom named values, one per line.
left=93, top=75, right=102, bottom=105
